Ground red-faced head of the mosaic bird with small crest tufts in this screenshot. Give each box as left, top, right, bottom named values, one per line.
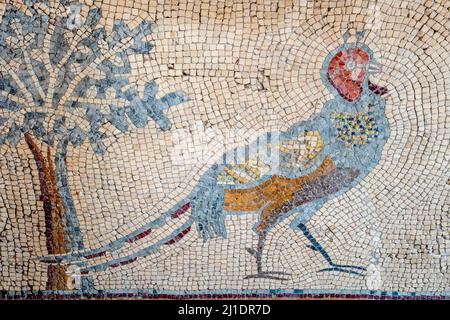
left=322, top=32, right=387, bottom=102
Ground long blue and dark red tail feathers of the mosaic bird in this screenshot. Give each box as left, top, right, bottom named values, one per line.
left=38, top=199, right=193, bottom=274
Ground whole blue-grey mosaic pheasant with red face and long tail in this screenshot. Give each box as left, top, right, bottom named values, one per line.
left=41, top=32, right=389, bottom=280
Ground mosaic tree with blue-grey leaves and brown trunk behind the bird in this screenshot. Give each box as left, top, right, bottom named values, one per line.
left=0, top=0, right=187, bottom=290
